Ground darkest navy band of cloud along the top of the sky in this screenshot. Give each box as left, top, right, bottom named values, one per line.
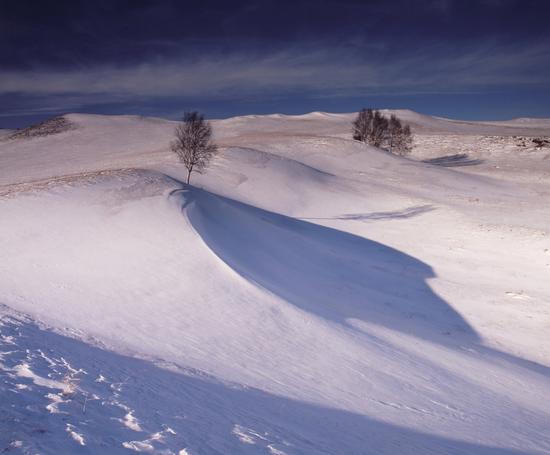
left=0, top=0, right=548, bottom=68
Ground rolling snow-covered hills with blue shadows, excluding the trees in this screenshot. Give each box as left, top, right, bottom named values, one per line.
left=0, top=111, right=550, bottom=455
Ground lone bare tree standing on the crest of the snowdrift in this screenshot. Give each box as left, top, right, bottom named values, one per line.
left=170, top=111, right=218, bottom=183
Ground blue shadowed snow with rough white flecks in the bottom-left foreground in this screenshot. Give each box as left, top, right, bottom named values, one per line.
left=0, top=317, right=540, bottom=455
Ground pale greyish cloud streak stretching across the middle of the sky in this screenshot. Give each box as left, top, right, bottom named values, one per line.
left=0, top=44, right=550, bottom=101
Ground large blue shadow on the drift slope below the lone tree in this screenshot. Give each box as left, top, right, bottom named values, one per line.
left=171, top=186, right=550, bottom=375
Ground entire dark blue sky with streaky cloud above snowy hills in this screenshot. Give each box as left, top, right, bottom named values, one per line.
left=0, top=0, right=550, bottom=127
